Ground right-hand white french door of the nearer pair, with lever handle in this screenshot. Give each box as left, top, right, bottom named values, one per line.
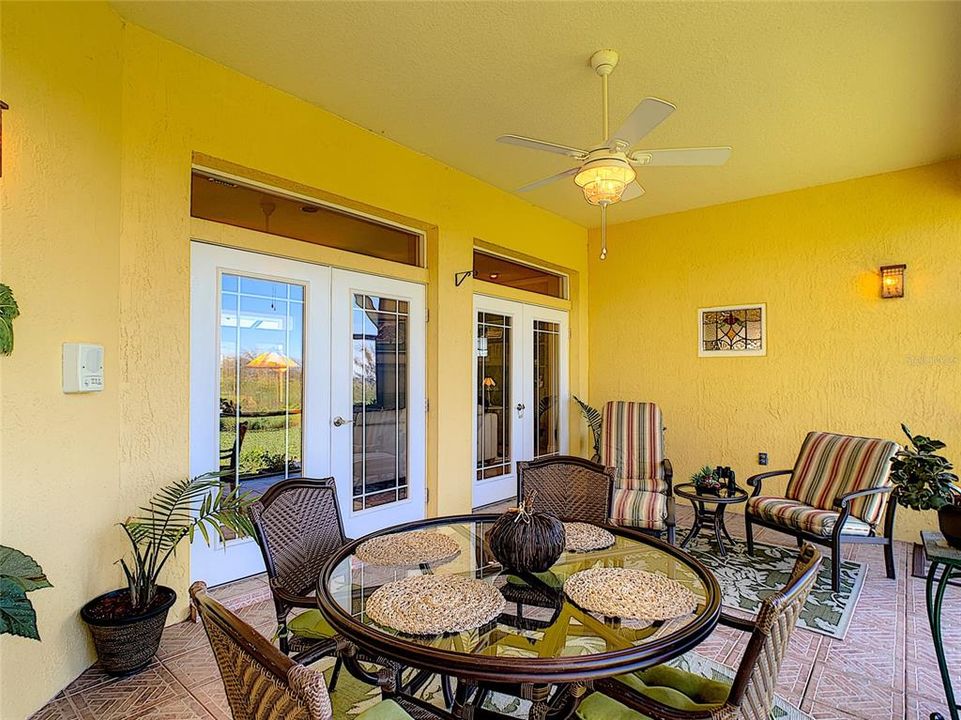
left=330, top=270, right=427, bottom=537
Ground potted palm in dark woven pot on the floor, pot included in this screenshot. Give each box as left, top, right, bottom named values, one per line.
left=80, top=473, right=254, bottom=675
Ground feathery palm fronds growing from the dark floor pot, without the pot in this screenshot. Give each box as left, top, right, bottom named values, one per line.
left=120, top=473, right=256, bottom=612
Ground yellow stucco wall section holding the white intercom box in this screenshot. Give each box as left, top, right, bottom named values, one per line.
left=0, top=3, right=124, bottom=720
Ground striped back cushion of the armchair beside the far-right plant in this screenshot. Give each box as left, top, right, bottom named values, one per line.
left=785, top=432, right=898, bottom=525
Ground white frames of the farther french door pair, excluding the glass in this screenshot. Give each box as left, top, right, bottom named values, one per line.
left=471, top=294, right=570, bottom=508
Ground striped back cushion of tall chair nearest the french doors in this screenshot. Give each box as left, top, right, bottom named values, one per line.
left=601, top=401, right=664, bottom=480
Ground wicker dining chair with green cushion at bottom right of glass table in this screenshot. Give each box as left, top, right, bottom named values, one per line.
left=577, top=543, right=821, bottom=720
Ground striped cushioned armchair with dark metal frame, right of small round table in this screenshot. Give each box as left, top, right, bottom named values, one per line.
left=744, top=432, right=898, bottom=592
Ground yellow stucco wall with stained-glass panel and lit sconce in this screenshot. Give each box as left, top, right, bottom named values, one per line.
left=589, top=161, right=961, bottom=541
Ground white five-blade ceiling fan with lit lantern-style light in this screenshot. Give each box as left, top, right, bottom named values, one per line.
left=497, top=50, right=731, bottom=260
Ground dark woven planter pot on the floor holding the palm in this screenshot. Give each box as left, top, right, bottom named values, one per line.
left=80, top=585, right=177, bottom=675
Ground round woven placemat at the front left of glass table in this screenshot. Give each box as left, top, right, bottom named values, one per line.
left=367, top=575, right=507, bottom=635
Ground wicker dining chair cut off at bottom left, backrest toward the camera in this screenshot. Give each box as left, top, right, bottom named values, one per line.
left=190, top=582, right=449, bottom=720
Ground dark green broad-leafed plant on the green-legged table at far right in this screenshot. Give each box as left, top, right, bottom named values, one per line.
left=891, top=423, right=959, bottom=510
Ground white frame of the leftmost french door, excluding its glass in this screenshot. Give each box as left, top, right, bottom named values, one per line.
left=189, top=241, right=330, bottom=585
